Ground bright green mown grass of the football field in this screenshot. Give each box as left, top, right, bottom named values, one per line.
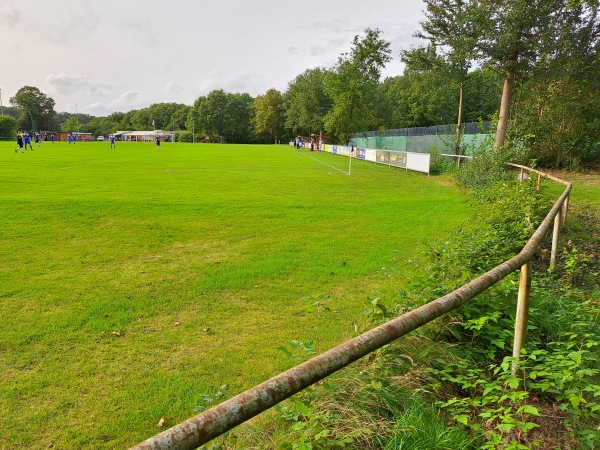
left=0, top=142, right=468, bottom=449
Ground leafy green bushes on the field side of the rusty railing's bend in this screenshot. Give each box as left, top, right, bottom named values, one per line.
left=406, top=175, right=548, bottom=320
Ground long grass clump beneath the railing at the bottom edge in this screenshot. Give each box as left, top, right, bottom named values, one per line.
left=272, top=336, right=478, bottom=450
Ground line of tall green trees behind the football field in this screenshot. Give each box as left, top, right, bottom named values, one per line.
left=0, top=0, right=600, bottom=167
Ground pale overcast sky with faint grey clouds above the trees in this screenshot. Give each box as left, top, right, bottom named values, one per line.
left=0, top=0, right=425, bottom=116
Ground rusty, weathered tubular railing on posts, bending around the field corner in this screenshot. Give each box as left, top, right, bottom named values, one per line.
left=131, top=164, right=571, bottom=450
